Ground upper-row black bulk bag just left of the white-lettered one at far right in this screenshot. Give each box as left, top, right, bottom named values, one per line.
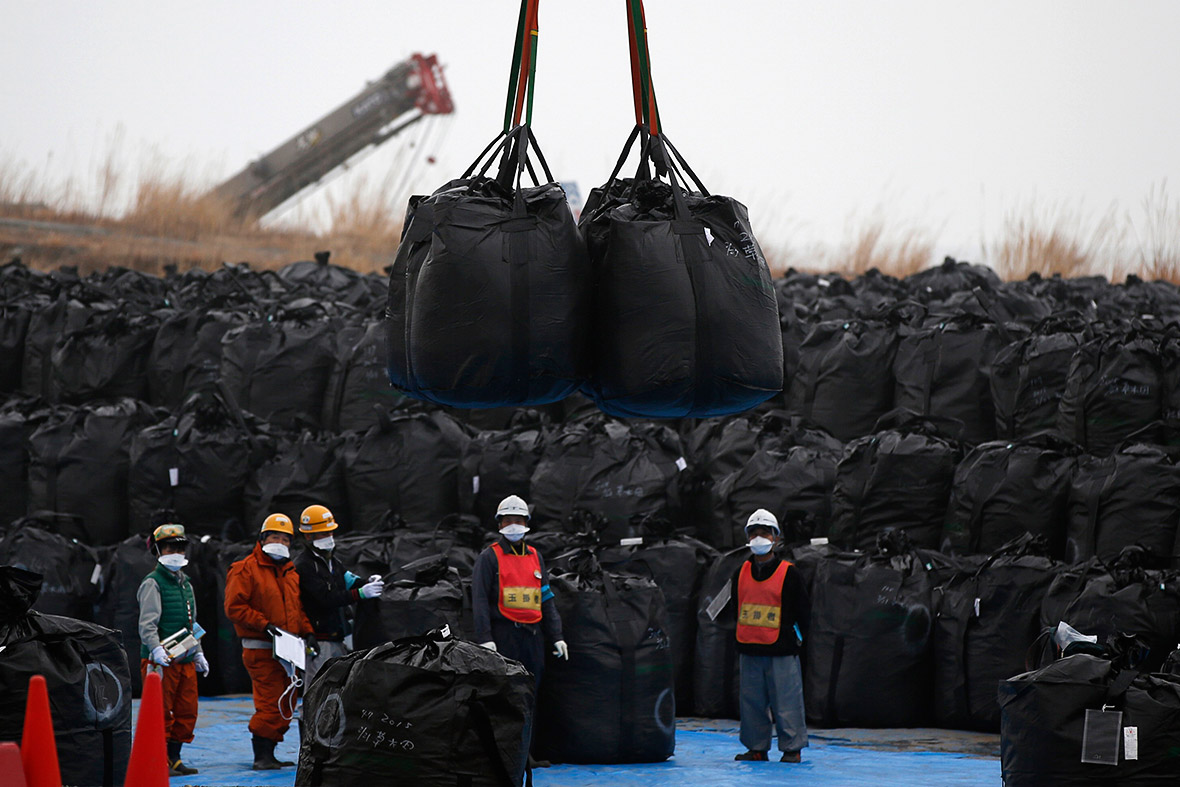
left=990, top=317, right=1086, bottom=440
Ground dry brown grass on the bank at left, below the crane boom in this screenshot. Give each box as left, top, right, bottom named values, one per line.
left=0, top=149, right=402, bottom=274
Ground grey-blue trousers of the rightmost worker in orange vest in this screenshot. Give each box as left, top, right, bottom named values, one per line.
left=740, top=654, right=807, bottom=752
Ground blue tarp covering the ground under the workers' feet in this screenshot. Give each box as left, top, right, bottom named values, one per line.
left=156, top=697, right=1001, bottom=787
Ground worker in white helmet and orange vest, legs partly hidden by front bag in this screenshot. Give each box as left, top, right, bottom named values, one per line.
left=471, top=494, right=570, bottom=690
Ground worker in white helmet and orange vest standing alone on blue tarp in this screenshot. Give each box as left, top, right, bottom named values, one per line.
left=734, top=509, right=808, bottom=762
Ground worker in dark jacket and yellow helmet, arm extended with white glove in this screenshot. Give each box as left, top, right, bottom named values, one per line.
left=295, top=505, right=385, bottom=686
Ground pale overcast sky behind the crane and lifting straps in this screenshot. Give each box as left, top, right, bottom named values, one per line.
left=0, top=0, right=1180, bottom=257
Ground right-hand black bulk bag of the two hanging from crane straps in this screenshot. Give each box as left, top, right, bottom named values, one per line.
left=579, top=126, right=784, bottom=418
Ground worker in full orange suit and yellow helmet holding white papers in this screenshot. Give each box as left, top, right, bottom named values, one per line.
left=225, top=513, right=317, bottom=770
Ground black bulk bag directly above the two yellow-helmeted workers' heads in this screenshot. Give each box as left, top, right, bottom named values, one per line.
left=242, top=429, right=350, bottom=534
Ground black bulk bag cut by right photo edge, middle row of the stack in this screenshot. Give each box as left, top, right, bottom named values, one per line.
left=1066, top=444, right=1180, bottom=568
